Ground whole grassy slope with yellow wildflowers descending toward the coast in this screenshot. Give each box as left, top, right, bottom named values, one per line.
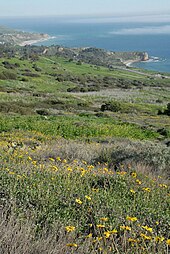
left=0, top=52, right=170, bottom=254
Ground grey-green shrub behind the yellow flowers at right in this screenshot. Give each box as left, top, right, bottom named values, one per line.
left=95, top=141, right=170, bottom=174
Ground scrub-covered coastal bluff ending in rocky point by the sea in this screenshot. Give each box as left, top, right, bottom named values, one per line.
left=44, top=45, right=149, bottom=68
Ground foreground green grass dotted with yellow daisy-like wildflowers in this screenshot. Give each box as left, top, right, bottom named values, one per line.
left=0, top=137, right=169, bottom=253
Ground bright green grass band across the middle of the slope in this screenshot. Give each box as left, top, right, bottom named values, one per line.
left=0, top=115, right=159, bottom=140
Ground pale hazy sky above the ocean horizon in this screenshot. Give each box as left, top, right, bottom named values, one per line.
left=0, top=0, right=170, bottom=17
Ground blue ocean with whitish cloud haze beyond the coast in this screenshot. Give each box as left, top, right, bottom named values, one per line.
left=0, top=17, right=170, bottom=73
